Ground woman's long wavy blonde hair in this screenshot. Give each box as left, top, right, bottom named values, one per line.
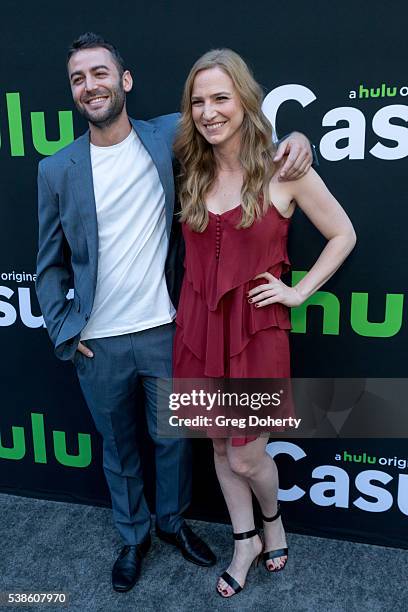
left=174, top=49, right=276, bottom=232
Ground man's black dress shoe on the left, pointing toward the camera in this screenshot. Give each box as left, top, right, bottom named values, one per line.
left=112, top=535, right=152, bottom=593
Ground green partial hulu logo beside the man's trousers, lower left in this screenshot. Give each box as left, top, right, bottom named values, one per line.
left=0, top=412, right=92, bottom=468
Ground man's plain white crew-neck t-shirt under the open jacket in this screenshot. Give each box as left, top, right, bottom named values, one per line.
left=81, top=129, right=175, bottom=340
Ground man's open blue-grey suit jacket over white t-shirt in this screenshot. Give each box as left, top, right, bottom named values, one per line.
left=36, top=114, right=183, bottom=360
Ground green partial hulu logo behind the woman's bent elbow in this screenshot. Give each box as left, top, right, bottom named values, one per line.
left=292, top=271, right=404, bottom=338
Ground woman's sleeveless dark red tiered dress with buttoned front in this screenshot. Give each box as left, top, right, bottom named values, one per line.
left=173, top=205, right=291, bottom=446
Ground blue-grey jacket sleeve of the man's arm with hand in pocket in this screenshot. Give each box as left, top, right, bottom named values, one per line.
left=36, top=163, right=72, bottom=346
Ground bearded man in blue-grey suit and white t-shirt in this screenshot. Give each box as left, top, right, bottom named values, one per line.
left=36, top=33, right=310, bottom=591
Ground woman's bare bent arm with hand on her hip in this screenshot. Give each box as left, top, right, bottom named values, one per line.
left=248, top=169, right=356, bottom=307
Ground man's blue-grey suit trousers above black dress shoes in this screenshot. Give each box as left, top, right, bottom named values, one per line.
left=74, top=323, right=191, bottom=544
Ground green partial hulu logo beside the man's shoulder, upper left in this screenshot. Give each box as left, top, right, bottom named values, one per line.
left=0, top=93, right=74, bottom=157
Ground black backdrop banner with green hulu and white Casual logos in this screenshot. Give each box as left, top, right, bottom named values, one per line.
left=0, top=0, right=408, bottom=547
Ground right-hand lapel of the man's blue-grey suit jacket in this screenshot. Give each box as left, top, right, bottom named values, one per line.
left=130, top=119, right=174, bottom=236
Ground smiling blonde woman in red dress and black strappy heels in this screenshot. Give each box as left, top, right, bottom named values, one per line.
left=174, top=49, right=355, bottom=597
